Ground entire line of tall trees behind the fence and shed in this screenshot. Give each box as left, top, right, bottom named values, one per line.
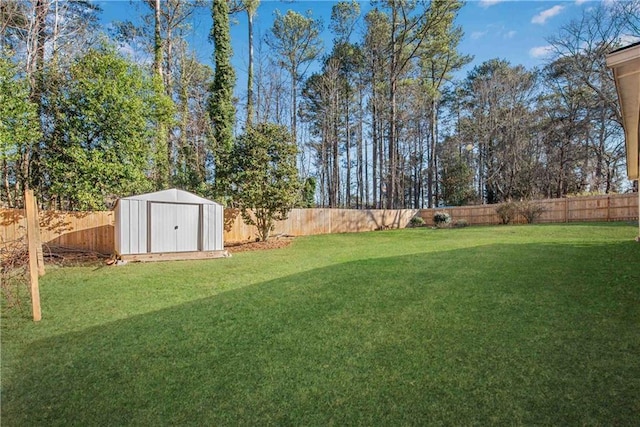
left=0, top=0, right=640, bottom=210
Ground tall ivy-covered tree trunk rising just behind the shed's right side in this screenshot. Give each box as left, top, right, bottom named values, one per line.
left=209, top=0, right=236, bottom=197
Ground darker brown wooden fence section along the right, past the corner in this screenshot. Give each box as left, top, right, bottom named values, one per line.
left=420, top=193, right=638, bottom=225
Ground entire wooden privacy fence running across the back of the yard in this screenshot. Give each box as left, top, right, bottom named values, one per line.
left=0, top=193, right=638, bottom=254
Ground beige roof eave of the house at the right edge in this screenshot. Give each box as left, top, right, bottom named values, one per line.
left=607, top=43, right=640, bottom=179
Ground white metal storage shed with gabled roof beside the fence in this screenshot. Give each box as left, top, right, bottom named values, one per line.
left=114, top=188, right=226, bottom=260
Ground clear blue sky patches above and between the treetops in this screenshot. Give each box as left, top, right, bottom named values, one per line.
left=99, top=0, right=612, bottom=82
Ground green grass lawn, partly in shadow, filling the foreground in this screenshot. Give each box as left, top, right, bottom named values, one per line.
left=1, top=224, right=640, bottom=426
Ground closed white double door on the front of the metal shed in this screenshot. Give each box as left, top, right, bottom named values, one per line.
left=149, top=203, right=200, bottom=253
